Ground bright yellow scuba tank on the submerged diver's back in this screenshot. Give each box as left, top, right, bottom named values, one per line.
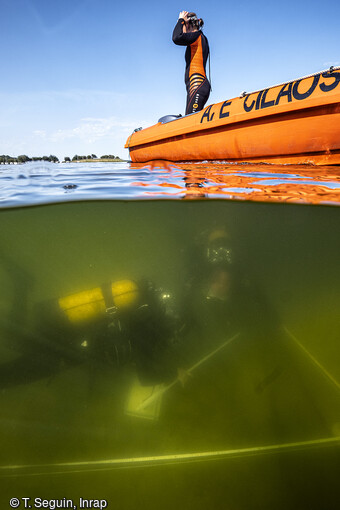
left=58, top=280, right=140, bottom=322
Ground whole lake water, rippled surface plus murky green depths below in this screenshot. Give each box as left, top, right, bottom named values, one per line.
left=0, top=162, right=340, bottom=510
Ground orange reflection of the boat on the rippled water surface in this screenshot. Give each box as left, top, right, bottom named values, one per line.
left=131, top=161, right=340, bottom=204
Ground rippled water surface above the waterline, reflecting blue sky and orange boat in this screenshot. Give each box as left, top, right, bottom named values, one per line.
left=0, top=161, right=340, bottom=207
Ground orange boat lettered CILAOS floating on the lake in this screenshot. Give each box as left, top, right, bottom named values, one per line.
left=125, top=67, right=340, bottom=165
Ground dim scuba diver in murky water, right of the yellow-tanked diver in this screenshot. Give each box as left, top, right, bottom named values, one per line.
left=180, top=226, right=280, bottom=378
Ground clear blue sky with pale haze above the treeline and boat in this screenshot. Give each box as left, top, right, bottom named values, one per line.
left=0, top=0, right=340, bottom=160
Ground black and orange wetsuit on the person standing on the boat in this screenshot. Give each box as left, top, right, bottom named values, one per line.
left=172, top=18, right=210, bottom=115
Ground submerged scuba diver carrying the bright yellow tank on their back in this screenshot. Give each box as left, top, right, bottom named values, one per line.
left=0, top=255, right=178, bottom=389
